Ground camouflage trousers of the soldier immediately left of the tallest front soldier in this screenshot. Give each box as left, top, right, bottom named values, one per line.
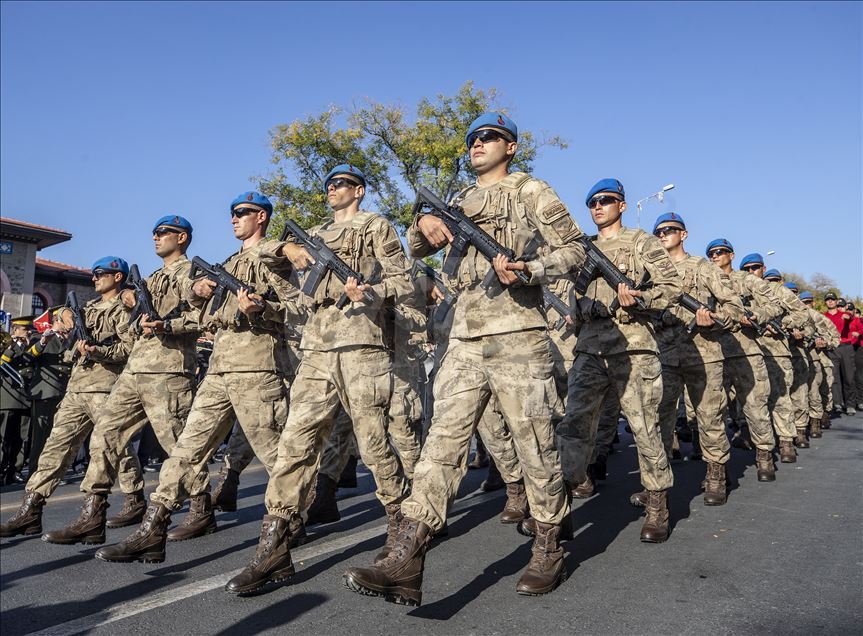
left=265, top=347, right=408, bottom=519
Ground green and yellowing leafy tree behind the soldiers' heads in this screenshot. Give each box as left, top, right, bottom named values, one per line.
left=255, top=82, right=567, bottom=235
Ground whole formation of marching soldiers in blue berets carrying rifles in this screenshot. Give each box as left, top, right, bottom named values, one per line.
left=0, top=113, right=863, bottom=605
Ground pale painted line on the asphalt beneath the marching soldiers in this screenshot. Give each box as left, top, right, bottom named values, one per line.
left=22, top=491, right=500, bottom=636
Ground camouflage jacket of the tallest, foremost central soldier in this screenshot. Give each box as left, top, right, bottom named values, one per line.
left=407, top=172, right=584, bottom=338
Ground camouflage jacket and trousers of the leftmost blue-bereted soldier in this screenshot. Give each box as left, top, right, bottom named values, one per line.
left=26, top=296, right=144, bottom=498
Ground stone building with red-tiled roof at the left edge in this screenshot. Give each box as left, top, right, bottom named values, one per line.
left=0, top=217, right=96, bottom=317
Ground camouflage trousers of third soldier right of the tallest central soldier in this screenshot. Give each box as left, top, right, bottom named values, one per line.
left=725, top=355, right=776, bottom=451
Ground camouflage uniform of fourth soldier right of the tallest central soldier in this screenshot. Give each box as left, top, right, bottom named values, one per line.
left=758, top=282, right=811, bottom=441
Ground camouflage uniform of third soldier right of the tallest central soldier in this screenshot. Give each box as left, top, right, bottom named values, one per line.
left=720, top=271, right=782, bottom=451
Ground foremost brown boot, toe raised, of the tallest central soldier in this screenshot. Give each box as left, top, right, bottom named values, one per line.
left=344, top=517, right=432, bottom=606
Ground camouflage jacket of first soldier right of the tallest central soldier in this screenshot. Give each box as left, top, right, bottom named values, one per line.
left=575, top=228, right=683, bottom=356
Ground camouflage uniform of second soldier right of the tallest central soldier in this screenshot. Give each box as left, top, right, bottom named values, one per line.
left=658, top=255, right=743, bottom=464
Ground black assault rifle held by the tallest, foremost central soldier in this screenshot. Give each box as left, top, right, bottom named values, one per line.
left=413, top=187, right=530, bottom=291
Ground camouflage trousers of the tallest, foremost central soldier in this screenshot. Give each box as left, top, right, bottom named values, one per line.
left=402, top=329, right=569, bottom=530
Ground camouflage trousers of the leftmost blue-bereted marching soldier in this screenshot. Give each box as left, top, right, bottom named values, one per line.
left=26, top=392, right=144, bottom=498
